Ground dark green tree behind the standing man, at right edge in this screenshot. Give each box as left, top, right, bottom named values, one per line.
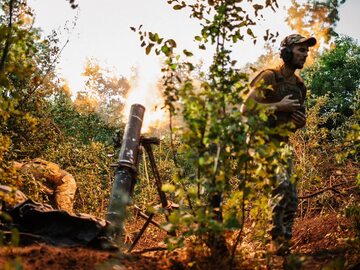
left=302, top=37, right=360, bottom=129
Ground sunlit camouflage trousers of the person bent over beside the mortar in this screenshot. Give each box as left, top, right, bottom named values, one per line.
left=54, top=174, right=76, bottom=213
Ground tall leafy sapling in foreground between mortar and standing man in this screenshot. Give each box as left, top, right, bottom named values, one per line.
left=133, top=0, right=288, bottom=255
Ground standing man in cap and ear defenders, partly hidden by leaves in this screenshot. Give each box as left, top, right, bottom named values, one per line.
left=242, top=34, right=316, bottom=255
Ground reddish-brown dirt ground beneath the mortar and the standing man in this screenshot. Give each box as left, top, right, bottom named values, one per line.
left=0, top=214, right=360, bottom=270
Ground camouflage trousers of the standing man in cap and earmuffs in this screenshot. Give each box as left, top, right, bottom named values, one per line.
left=270, top=158, right=298, bottom=240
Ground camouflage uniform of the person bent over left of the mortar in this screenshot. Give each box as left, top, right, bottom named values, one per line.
left=19, top=158, right=76, bottom=213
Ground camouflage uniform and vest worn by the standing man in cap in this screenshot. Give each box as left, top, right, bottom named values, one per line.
left=252, top=68, right=306, bottom=240
